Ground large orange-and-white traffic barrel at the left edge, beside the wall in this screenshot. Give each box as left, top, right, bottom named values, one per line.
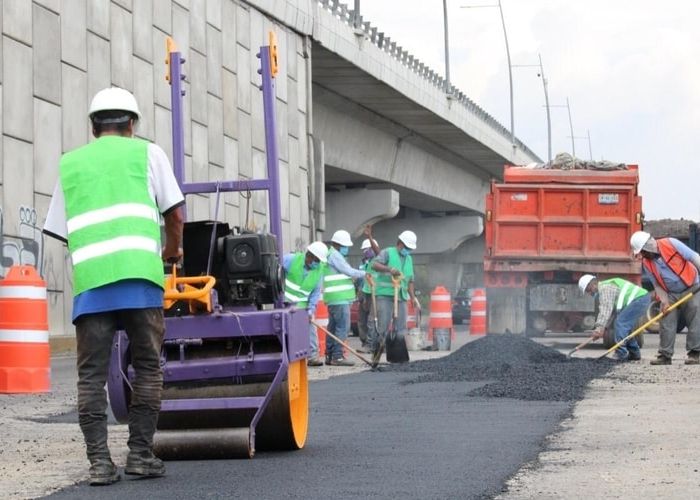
left=0, top=266, right=51, bottom=393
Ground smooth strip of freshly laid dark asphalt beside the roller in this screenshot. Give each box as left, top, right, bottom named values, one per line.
left=50, top=366, right=571, bottom=500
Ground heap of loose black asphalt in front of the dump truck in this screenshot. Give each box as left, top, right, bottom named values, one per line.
left=393, top=334, right=614, bottom=401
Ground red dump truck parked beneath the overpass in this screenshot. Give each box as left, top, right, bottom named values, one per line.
left=484, top=165, right=642, bottom=336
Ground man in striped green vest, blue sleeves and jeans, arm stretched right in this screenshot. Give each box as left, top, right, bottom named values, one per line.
left=323, top=229, right=372, bottom=366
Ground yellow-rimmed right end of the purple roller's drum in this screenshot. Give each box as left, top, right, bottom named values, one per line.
left=255, top=359, right=309, bottom=450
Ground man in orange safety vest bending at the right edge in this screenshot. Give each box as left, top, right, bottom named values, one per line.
left=630, top=231, right=700, bottom=365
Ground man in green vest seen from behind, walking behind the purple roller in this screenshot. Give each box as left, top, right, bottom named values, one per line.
left=44, top=88, right=184, bottom=485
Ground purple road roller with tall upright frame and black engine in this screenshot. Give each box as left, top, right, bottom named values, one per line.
left=108, top=33, right=310, bottom=460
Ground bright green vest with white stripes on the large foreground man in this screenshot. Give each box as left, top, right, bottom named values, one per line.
left=60, top=136, right=164, bottom=295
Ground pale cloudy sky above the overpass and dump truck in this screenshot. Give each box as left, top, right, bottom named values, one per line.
left=358, top=0, right=700, bottom=221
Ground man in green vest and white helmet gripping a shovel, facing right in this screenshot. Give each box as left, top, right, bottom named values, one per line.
left=369, top=231, right=420, bottom=364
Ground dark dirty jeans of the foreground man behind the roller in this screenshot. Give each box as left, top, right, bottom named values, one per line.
left=75, top=308, right=165, bottom=463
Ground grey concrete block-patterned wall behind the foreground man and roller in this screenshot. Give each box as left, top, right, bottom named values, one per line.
left=0, top=0, right=309, bottom=335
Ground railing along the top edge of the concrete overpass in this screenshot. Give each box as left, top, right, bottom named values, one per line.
left=318, top=0, right=537, bottom=158
